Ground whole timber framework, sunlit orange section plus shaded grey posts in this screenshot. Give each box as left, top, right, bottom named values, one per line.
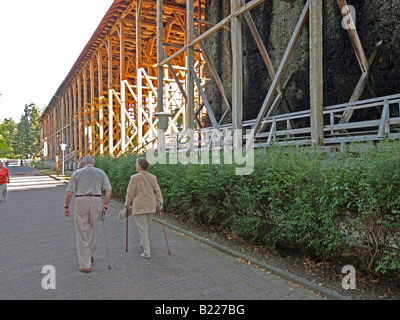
left=41, top=0, right=394, bottom=162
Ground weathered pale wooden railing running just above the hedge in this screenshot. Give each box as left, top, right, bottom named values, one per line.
left=166, top=94, right=400, bottom=150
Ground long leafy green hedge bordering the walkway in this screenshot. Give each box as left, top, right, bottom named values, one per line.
left=96, top=141, right=400, bottom=273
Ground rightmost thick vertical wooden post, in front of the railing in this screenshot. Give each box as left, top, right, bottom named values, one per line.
left=309, top=0, right=324, bottom=146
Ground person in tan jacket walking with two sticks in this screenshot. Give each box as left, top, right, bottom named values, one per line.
left=125, top=158, right=163, bottom=259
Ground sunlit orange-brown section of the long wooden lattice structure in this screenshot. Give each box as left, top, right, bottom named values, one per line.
left=41, top=0, right=209, bottom=162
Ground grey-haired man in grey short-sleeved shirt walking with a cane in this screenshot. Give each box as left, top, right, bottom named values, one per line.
left=64, top=155, right=111, bottom=273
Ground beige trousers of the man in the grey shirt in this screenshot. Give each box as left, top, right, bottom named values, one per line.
left=74, top=197, right=103, bottom=269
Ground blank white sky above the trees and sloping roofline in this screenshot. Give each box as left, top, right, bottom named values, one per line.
left=0, top=0, right=114, bottom=123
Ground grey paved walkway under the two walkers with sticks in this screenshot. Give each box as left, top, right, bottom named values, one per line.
left=0, top=166, right=342, bottom=300
